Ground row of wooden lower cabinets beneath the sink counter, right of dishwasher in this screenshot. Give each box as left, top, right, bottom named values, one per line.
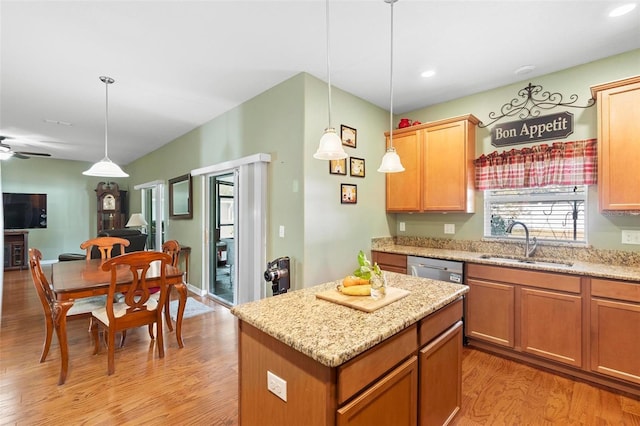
left=465, top=263, right=640, bottom=397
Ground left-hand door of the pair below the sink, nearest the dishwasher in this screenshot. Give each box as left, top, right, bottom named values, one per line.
left=466, top=278, right=515, bottom=348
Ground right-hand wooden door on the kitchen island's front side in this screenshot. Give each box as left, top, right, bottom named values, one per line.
left=419, top=321, right=462, bottom=426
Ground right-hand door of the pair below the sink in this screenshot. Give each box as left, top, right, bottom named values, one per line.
left=520, top=288, right=582, bottom=367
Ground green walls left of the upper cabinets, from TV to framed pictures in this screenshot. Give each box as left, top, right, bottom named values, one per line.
left=1, top=73, right=395, bottom=288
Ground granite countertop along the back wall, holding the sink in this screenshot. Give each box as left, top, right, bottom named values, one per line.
left=372, top=244, right=640, bottom=284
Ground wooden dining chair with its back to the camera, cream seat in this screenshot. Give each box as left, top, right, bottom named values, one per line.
left=91, top=251, right=171, bottom=375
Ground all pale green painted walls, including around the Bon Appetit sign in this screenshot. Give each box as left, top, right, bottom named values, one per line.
left=0, top=50, right=640, bottom=296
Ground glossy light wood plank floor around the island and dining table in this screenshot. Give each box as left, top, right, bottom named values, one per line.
left=0, top=271, right=640, bottom=426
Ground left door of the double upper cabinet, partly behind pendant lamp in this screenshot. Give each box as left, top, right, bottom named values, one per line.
left=386, top=132, right=422, bottom=212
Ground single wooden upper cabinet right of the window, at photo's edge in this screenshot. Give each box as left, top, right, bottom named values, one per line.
left=591, top=76, right=640, bottom=211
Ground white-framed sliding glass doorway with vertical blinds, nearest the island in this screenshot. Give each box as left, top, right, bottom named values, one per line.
left=191, top=153, right=271, bottom=305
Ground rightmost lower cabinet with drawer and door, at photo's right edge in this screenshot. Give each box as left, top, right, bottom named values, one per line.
left=591, top=279, right=640, bottom=385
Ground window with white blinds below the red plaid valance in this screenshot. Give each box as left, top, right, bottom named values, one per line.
left=484, top=185, right=588, bottom=243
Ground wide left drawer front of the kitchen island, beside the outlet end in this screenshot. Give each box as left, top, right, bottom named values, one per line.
left=338, top=324, right=418, bottom=404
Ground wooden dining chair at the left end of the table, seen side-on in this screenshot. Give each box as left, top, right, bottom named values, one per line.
left=29, top=248, right=106, bottom=362
